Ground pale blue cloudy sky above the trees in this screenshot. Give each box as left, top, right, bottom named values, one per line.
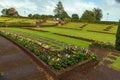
left=0, top=0, right=120, bottom=21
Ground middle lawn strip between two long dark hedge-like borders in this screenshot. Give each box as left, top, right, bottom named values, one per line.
left=33, top=27, right=115, bottom=43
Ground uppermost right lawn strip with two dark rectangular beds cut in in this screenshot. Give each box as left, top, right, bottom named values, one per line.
left=56, top=22, right=117, bottom=33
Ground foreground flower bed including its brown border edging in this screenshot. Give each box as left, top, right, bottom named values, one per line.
left=0, top=31, right=97, bottom=80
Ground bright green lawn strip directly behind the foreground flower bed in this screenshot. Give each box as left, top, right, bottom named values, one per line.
left=0, top=28, right=90, bottom=48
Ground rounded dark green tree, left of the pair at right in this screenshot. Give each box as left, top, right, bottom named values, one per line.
left=81, top=10, right=95, bottom=21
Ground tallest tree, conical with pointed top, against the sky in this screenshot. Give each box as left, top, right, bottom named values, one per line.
left=54, top=1, right=68, bottom=20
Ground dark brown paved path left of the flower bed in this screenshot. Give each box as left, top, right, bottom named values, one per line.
left=0, top=36, right=49, bottom=80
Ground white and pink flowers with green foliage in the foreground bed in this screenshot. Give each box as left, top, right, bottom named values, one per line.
left=0, top=31, right=97, bottom=70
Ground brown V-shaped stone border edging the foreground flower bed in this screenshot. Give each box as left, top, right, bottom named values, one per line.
left=0, top=34, right=96, bottom=80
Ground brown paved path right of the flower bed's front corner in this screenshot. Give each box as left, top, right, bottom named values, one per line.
left=62, top=48, right=120, bottom=80
